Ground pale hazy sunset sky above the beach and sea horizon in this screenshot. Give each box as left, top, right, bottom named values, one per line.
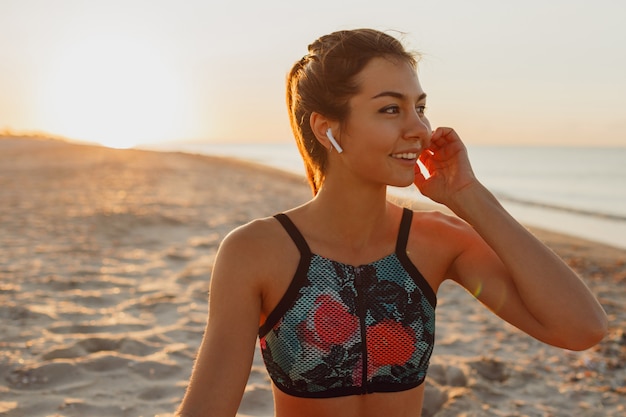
left=0, top=0, right=626, bottom=147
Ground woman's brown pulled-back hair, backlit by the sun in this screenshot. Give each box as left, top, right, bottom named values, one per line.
left=287, top=29, right=417, bottom=195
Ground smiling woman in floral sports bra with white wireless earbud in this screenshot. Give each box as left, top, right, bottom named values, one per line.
left=178, top=29, right=607, bottom=417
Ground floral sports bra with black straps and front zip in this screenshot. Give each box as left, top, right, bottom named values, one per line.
left=259, top=209, right=437, bottom=398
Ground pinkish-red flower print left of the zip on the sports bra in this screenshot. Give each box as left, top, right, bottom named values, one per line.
left=313, top=295, right=359, bottom=345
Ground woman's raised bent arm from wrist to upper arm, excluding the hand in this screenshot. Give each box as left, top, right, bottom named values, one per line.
left=444, top=186, right=607, bottom=350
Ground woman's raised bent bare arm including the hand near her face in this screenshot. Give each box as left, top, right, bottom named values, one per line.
left=416, top=129, right=607, bottom=350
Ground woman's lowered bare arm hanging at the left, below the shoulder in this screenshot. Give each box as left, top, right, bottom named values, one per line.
left=176, top=227, right=261, bottom=417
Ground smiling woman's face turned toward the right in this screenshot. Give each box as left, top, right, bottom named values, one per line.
left=340, top=58, right=431, bottom=187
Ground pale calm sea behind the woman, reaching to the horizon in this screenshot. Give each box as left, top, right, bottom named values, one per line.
left=143, top=142, right=626, bottom=249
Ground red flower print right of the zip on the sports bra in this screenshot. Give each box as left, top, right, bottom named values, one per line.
left=367, top=320, right=415, bottom=366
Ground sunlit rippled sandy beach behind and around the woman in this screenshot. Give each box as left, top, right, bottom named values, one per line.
left=0, top=137, right=626, bottom=417
